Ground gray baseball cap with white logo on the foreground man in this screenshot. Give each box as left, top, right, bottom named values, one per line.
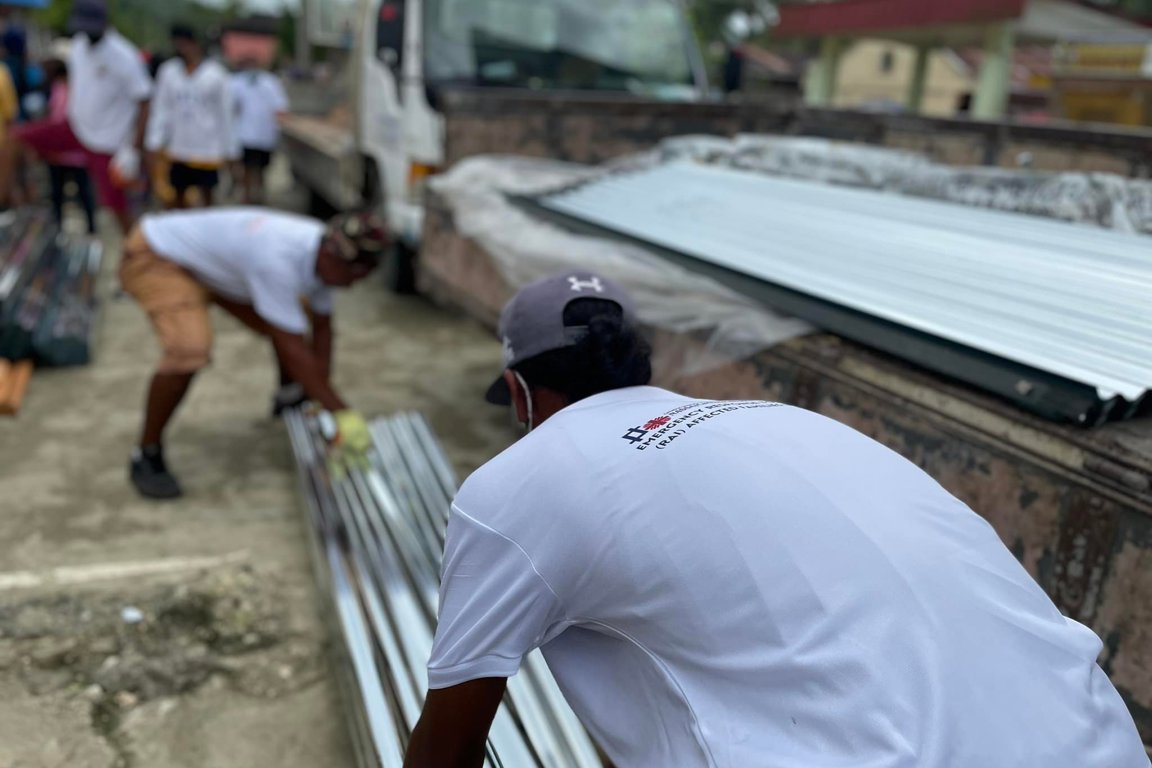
left=485, top=272, right=636, bottom=405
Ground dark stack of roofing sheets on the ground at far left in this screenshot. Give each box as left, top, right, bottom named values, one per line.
left=0, top=210, right=103, bottom=365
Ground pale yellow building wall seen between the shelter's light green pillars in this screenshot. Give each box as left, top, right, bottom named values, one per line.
left=834, top=40, right=975, bottom=117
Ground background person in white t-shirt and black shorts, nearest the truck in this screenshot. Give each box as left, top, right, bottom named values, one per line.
left=232, top=60, right=288, bottom=204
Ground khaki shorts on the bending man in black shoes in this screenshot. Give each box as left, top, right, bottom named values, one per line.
left=120, top=227, right=212, bottom=373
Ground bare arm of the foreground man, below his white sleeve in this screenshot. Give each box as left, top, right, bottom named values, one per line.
left=404, top=677, right=508, bottom=768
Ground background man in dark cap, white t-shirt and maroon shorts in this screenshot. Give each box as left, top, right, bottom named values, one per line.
left=0, top=0, right=152, bottom=233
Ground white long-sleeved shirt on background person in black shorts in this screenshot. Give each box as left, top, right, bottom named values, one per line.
left=146, top=59, right=240, bottom=166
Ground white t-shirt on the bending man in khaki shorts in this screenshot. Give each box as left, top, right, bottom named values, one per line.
left=141, top=207, right=332, bottom=334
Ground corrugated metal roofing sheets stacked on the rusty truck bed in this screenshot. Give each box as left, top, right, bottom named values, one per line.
left=530, top=162, right=1152, bottom=424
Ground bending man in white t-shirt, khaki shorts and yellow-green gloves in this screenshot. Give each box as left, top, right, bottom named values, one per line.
left=120, top=208, right=389, bottom=499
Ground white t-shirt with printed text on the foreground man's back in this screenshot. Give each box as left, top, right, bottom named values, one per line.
left=429, top=387, right=1149, bottom=768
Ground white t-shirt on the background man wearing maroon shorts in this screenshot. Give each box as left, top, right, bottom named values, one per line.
left=68, top=29, right=152, bottom=154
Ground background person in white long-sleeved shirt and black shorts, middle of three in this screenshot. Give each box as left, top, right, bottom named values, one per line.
left=145, top=24, right=238, bottom=208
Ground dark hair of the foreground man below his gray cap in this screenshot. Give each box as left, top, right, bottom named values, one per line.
left=514, top=298, right=652, bottom=403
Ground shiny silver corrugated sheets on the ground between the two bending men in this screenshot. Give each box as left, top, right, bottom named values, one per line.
left=286, top=411, right=601, bottom=768
